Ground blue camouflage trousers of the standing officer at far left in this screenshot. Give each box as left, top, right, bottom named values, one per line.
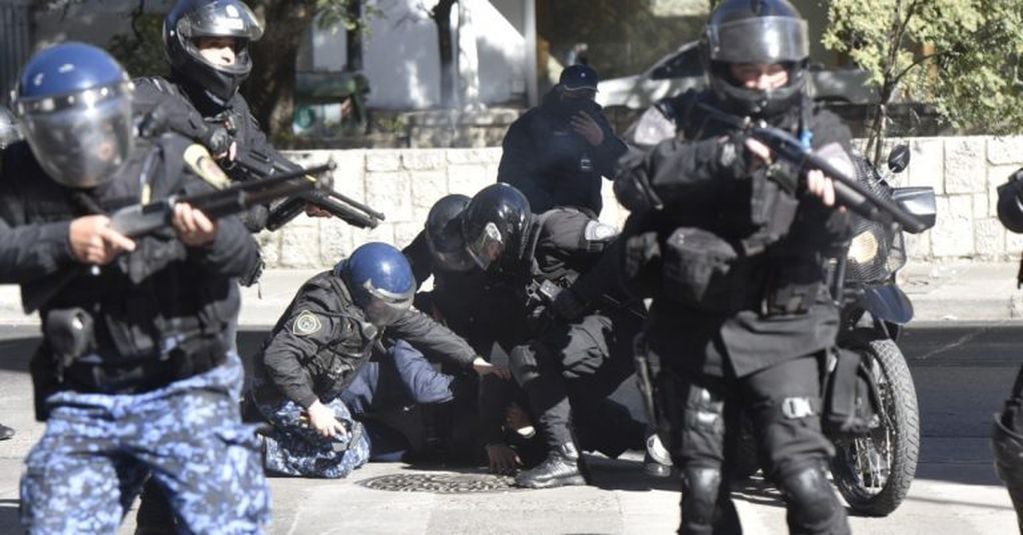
left=21, top=353, right=270, bottom=534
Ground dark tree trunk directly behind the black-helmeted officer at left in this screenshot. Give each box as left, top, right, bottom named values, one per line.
left=242, top=0, right=316, bottom=139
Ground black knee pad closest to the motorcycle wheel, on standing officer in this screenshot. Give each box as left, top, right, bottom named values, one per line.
left=779, top=466, right=844, bottom=533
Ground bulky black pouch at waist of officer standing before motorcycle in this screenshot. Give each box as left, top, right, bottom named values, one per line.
left=663, top=227, right=745, bottom=312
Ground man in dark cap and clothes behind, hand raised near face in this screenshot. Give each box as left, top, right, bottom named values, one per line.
left=497, top=64, right=625, bottom=216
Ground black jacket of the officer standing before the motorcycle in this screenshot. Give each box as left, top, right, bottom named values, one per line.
left=617, top=91, right=850, bottom=376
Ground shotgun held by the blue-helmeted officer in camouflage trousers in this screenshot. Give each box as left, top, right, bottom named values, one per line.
left=21, top=162, right=337, bottom=314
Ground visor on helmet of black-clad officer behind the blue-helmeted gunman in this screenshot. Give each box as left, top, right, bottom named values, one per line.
left=177, top=0, right=263, bottom=75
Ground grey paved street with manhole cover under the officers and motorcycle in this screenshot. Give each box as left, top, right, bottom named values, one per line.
left=0, top=322, right=1023, bottom=535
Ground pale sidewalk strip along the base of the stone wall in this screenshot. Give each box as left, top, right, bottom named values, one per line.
left=0, top=262, right=1023, bottom=326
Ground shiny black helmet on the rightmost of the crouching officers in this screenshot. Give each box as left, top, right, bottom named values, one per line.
left=461, top=183, right=531, bottom=269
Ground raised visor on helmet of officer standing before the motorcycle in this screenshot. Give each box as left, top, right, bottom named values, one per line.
left=707, top=16, right=810, bottom=64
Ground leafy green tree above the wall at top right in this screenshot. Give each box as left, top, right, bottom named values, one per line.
left=824, top=0, right=1023, bottom=161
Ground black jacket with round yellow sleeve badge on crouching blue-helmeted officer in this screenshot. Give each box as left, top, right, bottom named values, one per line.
left=255, top=271, right=476, bottom=407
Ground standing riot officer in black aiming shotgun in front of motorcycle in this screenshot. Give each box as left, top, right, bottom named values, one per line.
left=615, top=0, right=849, bottom=534
